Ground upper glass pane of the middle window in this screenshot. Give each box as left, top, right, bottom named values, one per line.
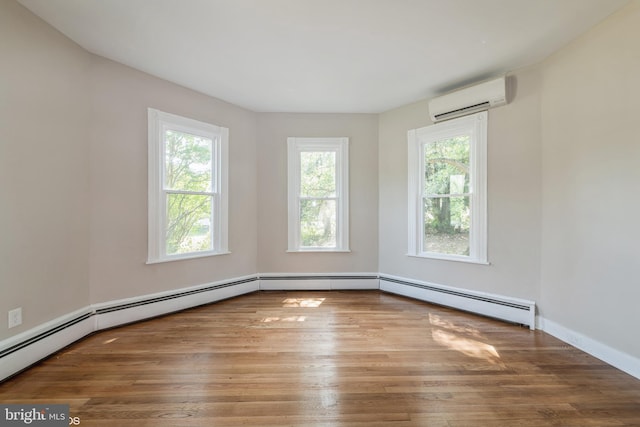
left=300, top=151, right=336, bottom=197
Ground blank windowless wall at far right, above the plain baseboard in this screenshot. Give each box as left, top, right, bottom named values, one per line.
left=540, top=1, right=640, bottom=358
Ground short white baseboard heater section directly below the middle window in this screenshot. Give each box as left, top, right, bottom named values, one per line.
left=260, top=273, right=379, bottom=291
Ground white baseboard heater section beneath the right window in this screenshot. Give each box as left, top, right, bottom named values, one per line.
left=380, top=275, right=536, bottom=330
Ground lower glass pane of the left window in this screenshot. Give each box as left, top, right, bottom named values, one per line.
left=166, top=194, right=213, bottom=255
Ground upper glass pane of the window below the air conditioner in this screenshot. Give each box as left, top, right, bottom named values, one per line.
left=424, top=135, right=470, bottom=195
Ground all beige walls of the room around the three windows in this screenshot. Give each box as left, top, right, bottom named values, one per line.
left=0, top=0, right=640, bottom=366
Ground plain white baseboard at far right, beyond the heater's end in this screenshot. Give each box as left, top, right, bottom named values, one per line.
left=538, top=317, right=640, bottom=379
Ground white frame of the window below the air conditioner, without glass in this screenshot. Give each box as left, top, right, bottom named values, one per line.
left=408, top=111, right=488, bottom=264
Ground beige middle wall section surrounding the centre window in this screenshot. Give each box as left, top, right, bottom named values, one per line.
left=258, top=113, right=378, bottom=273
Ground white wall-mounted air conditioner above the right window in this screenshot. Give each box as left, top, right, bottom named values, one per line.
left=429, top=76, right=507, bottom=122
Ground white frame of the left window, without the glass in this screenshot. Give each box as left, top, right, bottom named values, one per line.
left=147, top=108, right=229, bottom=264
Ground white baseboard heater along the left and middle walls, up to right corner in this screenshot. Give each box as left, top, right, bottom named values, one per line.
left=0, top=273, right=378, bottom=381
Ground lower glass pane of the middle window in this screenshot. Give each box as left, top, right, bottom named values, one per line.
left=300, top=199, right=336, bottom=248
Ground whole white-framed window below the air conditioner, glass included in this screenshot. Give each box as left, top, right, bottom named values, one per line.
left=408, top=111, right=487, bottom=263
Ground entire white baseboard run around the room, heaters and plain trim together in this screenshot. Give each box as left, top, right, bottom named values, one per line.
left=0, top=273, right=640, bottom=381
